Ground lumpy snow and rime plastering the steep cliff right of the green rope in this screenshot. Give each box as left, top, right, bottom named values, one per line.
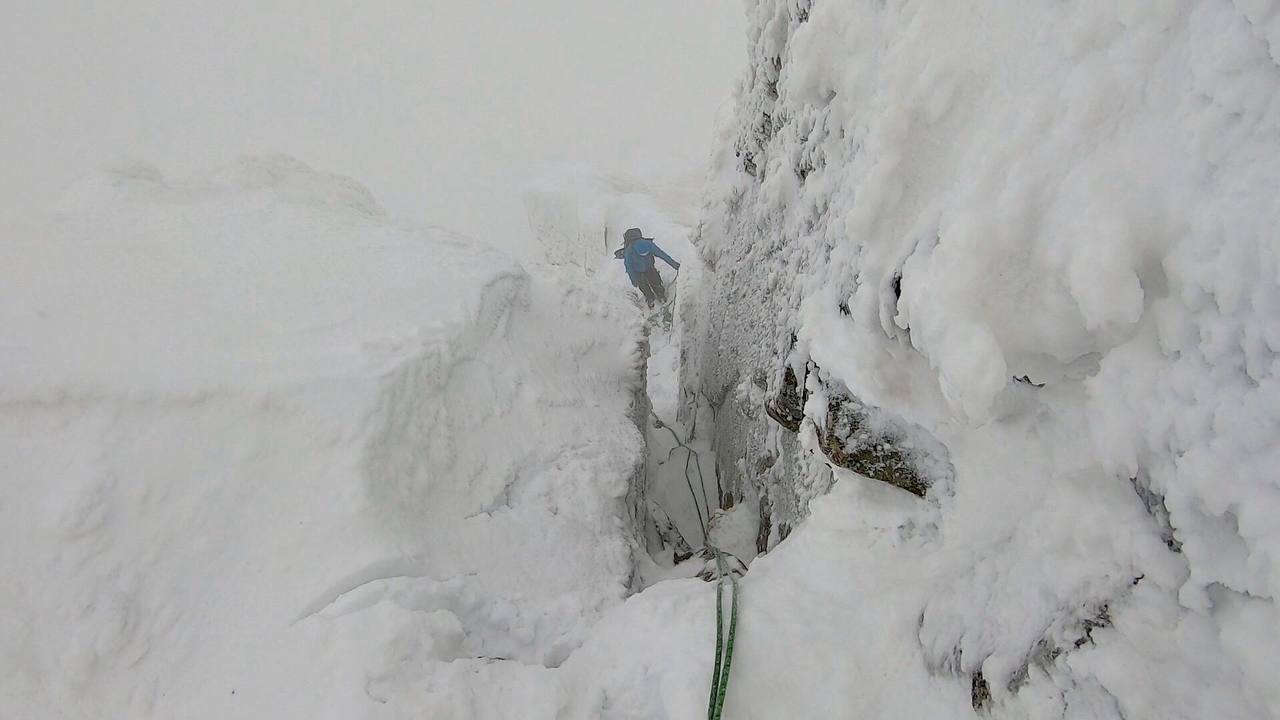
left=686, top=0, right=1280, bottom=720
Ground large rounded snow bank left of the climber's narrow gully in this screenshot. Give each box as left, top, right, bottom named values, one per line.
left=0, top=158, right=644, bottom=717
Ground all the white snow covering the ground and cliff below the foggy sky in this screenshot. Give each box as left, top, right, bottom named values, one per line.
left=0, top=0, right=1280, bottom=720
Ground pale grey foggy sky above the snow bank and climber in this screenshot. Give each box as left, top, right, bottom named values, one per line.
left=0, top=0, right=745, bottom=247
